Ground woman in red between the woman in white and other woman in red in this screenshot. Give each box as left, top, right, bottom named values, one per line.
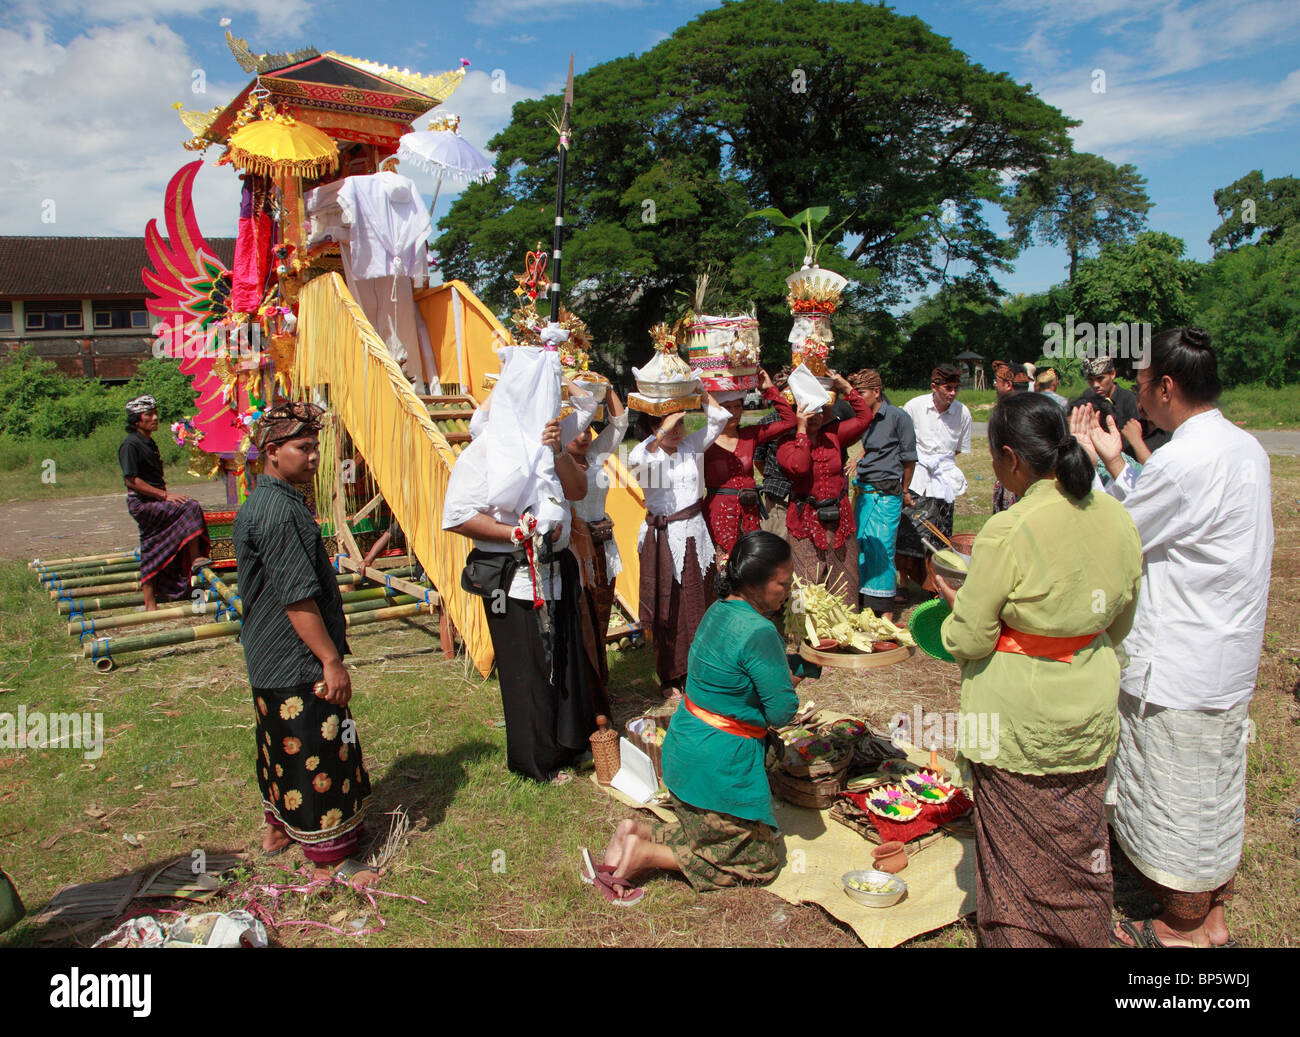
left=705, top=368, right=794, bottom=565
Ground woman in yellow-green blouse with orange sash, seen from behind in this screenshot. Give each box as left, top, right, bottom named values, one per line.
left=935, top=392, right=1141, bottom=947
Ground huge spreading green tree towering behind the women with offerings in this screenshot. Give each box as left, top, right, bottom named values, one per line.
left=436, top=0, right=1071, bottom=368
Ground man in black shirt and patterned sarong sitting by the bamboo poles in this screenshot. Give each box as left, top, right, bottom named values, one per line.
left=117, top=396, right=209, bottom=612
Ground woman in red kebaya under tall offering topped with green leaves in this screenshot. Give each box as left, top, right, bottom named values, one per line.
left=776, top=372, right=872, bottom=611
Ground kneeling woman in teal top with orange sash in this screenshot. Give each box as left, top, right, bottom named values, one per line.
left=597, top=530, right=800, bottom=901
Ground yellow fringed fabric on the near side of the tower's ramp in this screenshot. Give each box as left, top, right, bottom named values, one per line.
left=294, top=273, right=493, bottom=677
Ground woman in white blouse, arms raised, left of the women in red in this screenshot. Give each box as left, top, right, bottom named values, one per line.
left=628, top=394, right=731, bottom=698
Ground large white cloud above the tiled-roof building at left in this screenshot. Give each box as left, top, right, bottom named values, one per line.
left=0, top=19, right=243, bottom=237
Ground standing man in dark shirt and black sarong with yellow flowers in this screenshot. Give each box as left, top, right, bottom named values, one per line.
left=234, top=403, right=378, bottom=885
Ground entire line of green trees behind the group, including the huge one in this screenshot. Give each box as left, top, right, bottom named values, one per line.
left=436, top=0, right=1300, bottom=385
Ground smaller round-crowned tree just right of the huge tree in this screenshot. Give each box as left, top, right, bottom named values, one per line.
left=1006, top=152, right=1152, bottom=282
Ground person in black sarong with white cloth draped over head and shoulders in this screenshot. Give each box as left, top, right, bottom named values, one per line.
left=442, top=346, right=595, bottom=784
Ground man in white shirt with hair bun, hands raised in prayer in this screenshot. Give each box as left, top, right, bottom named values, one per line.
left=1071, top=327, right=1273, bottom=947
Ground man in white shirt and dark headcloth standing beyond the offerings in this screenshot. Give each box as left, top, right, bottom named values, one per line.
left=896, top=364, right=971, bottom=600
